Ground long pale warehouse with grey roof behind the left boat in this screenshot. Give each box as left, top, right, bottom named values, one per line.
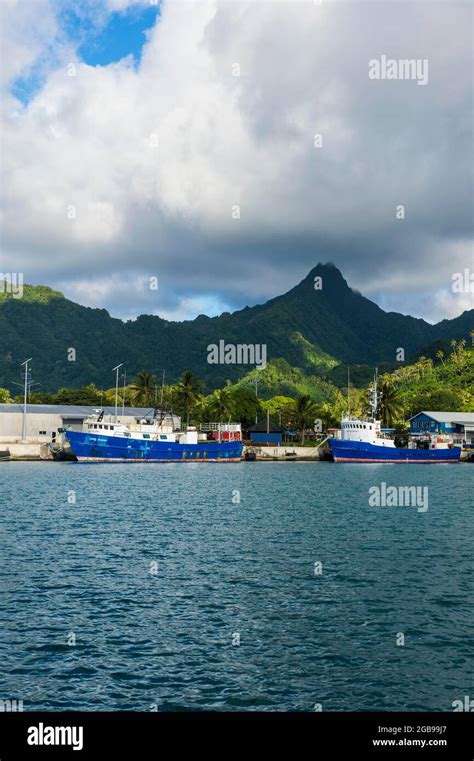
left=0, top=404, right=181, bottom=444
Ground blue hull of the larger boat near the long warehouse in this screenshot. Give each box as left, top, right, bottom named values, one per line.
left=65, top=431, right=242, bottom=462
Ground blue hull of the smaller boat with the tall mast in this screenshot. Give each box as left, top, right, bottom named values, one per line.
left=328, top=439, right=461, bottom=463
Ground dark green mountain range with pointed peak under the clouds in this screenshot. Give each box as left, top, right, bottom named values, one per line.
left=0, top=264, right=474, bottom=392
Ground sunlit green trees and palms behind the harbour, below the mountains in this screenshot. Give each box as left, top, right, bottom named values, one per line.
left=0, top=333, right=474, bottom=441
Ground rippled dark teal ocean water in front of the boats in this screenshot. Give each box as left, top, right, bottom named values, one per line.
left=0, top=462, right=474, bottom=711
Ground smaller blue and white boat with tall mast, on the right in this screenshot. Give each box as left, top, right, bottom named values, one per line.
left=328, top=373, right=461, bottom=463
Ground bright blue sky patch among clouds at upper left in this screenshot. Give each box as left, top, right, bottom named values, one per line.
left=11, top=0, right=160, bottom=105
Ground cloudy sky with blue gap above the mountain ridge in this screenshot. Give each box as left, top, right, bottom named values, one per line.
left=0, top=0, right=474, bottom=321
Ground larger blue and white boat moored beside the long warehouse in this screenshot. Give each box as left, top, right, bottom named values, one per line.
left=64, top=415, right=242, bottom=462
